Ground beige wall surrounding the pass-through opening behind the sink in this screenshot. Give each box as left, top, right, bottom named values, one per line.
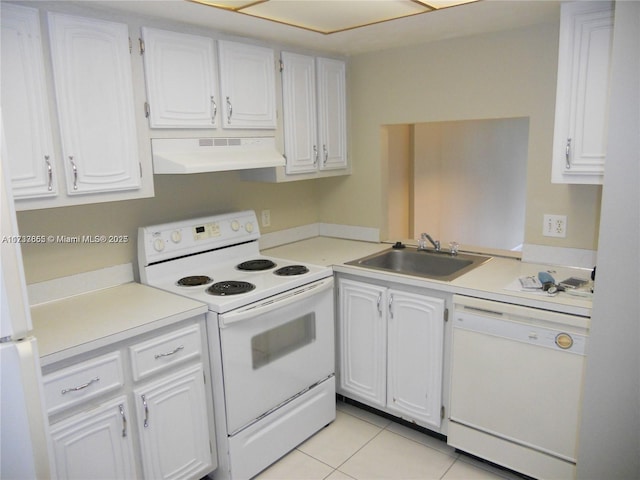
left=320, top=23, right=601, bottom=249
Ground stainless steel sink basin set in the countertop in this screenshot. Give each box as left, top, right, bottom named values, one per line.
left=347, top=248, right=491, bottom=281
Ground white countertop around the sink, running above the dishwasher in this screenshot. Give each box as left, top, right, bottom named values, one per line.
left=264, top=237, right=592, bottom=320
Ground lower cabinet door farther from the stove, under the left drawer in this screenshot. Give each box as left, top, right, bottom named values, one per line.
left=51, top=396, right=136, bottom=480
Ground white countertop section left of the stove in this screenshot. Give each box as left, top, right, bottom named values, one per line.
left=31, top=282, right=207, bottom=366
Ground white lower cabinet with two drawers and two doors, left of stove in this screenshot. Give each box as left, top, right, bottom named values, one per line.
left=43, top=319, right=217, bottom=480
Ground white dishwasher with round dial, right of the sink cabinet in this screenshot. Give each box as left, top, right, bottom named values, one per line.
left=447, top=295, right=589, bottom=480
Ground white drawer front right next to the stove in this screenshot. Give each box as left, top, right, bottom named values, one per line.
left=129, top=324, right=202, bottom=380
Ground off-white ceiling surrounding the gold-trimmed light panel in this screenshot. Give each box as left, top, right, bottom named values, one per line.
left=84, top=0, right=560, bottom=55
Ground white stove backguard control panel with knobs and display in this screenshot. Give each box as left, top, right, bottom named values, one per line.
left=138, top=210, right=260, bottom=265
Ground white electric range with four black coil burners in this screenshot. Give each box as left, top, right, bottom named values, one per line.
left=138, top=211, right=335, bottom=479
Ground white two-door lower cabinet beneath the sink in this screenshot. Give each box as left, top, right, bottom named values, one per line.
left=337, top=278, right=445, bottom=430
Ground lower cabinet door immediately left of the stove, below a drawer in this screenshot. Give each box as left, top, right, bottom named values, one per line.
left=135, top=364, right=213, bottom=479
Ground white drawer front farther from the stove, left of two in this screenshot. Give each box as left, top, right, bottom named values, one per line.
left=42, top=352, right=123, bottom=415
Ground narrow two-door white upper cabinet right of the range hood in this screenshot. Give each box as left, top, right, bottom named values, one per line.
left=282, top=52, right=347, bottom=174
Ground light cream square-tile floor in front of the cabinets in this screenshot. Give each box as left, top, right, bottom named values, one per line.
left=255, top=402, right=522, bottom=480
